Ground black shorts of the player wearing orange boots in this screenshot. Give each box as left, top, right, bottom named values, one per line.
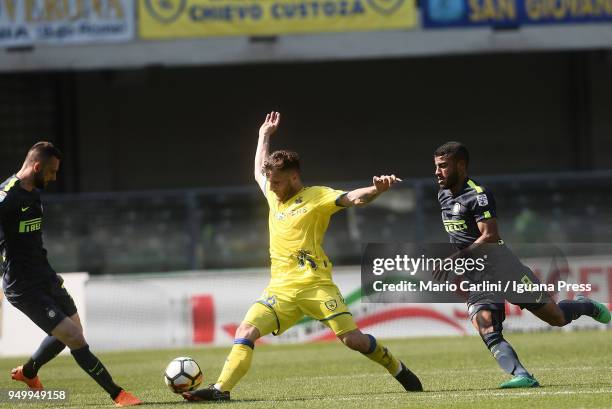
left=6, top=276, right=77, bottom=334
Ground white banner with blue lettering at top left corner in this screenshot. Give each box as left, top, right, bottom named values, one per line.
left=0, top=0, right=135, bottom=47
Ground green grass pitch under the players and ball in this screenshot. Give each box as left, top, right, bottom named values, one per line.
left=0, top=331, right=612, bottom=409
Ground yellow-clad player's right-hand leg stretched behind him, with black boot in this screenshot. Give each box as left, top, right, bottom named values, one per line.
left=298, top=284, right=423, bottom=391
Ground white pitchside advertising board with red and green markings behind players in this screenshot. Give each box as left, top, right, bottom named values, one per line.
left=86, top=257, right=612, bottom=350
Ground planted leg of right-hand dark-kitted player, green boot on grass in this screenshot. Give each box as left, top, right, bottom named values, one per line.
left=470, top=304, right=539, bottom=388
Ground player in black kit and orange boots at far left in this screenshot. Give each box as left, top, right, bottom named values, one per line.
left=0, top=142, right=142, bottom=407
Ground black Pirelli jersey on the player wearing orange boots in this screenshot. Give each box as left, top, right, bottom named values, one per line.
left=0, top=176, right=56, bottom=296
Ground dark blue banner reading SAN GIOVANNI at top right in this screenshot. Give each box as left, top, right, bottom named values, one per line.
left=422, top=0, right=612, bottom=28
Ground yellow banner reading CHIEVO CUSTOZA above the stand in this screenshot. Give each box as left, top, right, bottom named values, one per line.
left=138, top=0, right=416, bottom=39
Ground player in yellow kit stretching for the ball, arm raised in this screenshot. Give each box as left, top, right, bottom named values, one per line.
left=183, top=112, right=423, bottom=401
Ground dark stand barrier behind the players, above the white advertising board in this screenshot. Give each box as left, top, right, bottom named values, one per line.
left=44, top=171, right=612, bottom=274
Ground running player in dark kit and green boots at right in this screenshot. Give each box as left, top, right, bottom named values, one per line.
left=434, top=142, right=610, bottom=388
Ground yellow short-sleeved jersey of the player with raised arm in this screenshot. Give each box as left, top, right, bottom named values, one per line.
left=264, top=182, right=345, bottom=290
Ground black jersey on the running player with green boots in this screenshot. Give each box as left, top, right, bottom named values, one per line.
left=438, top=179, right=496, bottom=249
